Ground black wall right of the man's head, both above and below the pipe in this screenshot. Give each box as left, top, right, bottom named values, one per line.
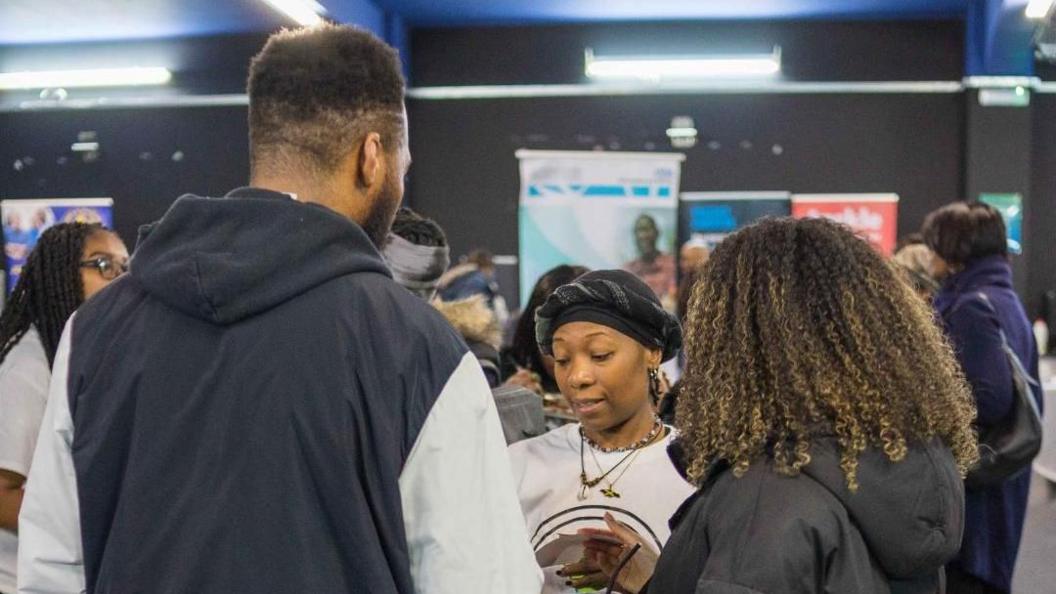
left=409, top=21, right=966, bottom=302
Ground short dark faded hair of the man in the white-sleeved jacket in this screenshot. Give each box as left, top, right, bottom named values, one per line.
left=247, top=24, right=403, bottom=172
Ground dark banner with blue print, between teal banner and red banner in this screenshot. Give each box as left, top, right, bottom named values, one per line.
left=679, top=191, right=792, bottom=249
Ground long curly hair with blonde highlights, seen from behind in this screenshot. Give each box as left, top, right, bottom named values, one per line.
left=677, top=214, right=978, bottom=490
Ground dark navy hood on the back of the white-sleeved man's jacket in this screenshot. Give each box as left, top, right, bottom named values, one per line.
left=130, top=188, right=391, bottom=324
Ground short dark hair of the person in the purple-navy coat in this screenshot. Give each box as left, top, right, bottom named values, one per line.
left=923, top=201, right=1008, bottom=264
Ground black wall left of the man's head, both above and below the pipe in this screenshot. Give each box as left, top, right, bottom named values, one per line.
left=0, top=34, right=267, bottom=247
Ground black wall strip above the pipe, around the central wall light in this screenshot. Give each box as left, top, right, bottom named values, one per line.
left=411, top=21, right=964, bottom=87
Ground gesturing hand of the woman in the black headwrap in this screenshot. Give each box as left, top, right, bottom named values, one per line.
left=579, top=514, right=660, bottom=594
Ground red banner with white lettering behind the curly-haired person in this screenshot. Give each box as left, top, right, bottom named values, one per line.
left=792, top=193, right=899, bottom=251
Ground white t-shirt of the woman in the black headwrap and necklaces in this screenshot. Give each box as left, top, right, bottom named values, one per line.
left=509, top=423, right=695, bottom=594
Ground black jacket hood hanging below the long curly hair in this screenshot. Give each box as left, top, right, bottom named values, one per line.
left=803, top=440, right=964, bottom=579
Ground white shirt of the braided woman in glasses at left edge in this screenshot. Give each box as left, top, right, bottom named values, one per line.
left=0, top=327, right=52, bottom=593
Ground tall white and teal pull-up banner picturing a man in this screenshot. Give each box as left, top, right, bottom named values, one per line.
left=516, top=150, right=684, bottom=304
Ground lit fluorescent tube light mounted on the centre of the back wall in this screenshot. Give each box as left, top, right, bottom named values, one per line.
left=586, top=48, right=781, bottom=80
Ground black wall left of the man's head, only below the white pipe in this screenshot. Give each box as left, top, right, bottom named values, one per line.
left=0, top=107, right=249, bottom=248
